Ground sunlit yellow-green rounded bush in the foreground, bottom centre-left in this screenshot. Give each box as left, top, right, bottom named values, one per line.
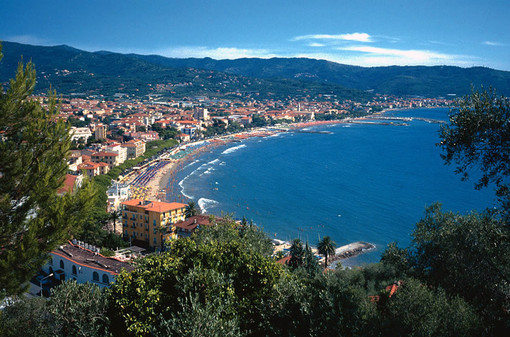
left=110, top=234, right=282, bottom=335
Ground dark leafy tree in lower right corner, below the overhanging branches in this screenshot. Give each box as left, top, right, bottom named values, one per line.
left=409, top=204, right=510, bottom=335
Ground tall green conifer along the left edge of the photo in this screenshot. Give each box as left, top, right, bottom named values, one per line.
left=0, top=45, right=93, bottom=298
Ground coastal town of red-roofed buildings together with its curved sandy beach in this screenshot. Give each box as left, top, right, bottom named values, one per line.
left=19, top=88, right=453, bottom=294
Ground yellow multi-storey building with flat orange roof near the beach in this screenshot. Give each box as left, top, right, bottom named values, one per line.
left=121, top=199, right=187, bottom=250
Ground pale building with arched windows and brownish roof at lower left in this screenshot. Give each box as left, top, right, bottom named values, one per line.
left=42, top=240, right=134, bottom=287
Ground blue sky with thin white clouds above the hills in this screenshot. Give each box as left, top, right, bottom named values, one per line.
left=0, top=0, right=510, bottom=71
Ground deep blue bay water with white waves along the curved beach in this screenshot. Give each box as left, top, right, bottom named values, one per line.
left=168, top=108, right=496, bottom=266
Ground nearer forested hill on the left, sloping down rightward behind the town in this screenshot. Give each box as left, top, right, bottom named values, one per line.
left=0, top=41, right=372, bottom=101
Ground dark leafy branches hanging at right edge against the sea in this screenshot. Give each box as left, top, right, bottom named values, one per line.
left=438, top=90, right=510, bottom=209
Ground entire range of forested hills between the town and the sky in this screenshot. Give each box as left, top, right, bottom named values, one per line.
left=0, top=42, right=510, bottom=100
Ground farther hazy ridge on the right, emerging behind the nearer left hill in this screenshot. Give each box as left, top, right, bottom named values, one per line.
left=132, top=55, right=510, bottom=97
